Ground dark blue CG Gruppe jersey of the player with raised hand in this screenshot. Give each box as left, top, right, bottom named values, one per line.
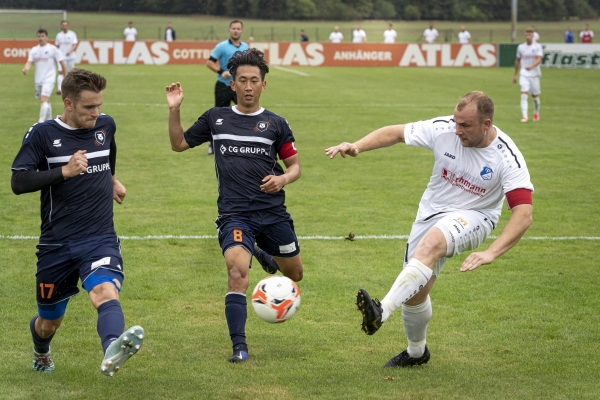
left=184, top=106, right=294, bottom=214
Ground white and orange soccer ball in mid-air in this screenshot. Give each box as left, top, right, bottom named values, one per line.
left=252, top=276, right=300, bottom=324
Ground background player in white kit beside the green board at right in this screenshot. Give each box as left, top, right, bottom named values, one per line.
left=513, top=29, right=544, bottom=122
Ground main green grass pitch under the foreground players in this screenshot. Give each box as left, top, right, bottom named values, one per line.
left=0, top=65, right=600, bottom=400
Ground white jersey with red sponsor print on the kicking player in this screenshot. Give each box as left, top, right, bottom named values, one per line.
left=404, top=115, right=533, bottom=225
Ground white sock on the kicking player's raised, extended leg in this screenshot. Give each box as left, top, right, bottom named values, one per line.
left=381, top=258, right=433, bottom=322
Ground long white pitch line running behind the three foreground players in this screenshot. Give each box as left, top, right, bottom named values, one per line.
left=0, top=235, right=600, bottom=241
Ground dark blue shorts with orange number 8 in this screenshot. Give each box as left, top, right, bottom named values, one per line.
left=215, top=211, right=300, bottom=258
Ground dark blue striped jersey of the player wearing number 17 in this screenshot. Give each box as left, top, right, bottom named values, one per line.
left=12, top=114, right=116, bottom=243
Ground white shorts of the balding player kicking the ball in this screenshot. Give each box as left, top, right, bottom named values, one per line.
left=404, top=210, right=495, bottom=276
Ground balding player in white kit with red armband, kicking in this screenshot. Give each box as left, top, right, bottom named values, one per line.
left=325, top=92, right=533, bottom=367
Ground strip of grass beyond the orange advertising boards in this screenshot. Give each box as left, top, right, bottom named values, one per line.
left=0, top=12, right=600, bottom=43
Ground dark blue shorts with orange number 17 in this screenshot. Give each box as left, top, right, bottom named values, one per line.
left=36, top=235, right=123, bottom=305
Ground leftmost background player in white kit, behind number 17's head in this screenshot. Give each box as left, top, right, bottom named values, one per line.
left=23, top=29, right=67, bottom=122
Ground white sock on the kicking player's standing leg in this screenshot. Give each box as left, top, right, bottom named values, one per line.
left=402, top=296, right=431, bottom=358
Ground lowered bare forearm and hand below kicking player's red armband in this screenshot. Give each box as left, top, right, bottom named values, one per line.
left=460, top=204, right=533, bottom=272
